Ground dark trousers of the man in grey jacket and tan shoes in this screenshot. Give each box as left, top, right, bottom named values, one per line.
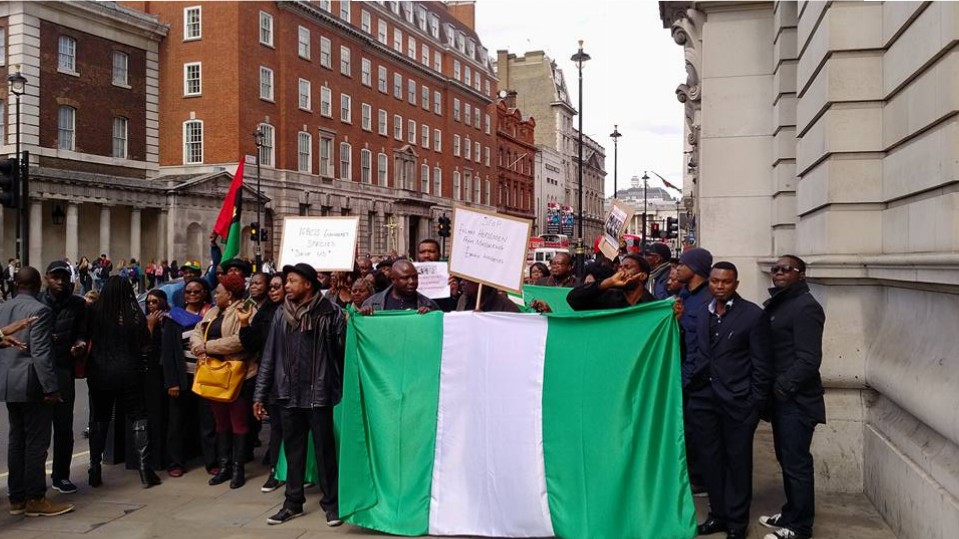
left=7, top=402, right=53, bottom=502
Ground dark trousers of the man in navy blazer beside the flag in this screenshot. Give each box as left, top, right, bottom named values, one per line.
left=687, top=385, right=759, bottom=532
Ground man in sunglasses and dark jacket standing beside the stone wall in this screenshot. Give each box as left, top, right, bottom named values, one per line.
left=759, top=255, right=826, bottom=539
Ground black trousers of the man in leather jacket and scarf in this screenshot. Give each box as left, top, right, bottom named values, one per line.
left=280, top=406, right=339, bottom=511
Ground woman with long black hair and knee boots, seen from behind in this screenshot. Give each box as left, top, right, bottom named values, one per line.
left=87, top=275, right=160, bottom=488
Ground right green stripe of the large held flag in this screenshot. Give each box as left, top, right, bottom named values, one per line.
left=543, top=301, right=696, bottom=539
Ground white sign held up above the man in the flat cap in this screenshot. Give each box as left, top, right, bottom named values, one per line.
left=280, top=216, right=360, bottom=271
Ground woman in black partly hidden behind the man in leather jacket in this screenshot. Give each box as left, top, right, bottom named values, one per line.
left=237, top=273, right=286, bottom=492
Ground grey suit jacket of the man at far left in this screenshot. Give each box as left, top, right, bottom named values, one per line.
left=0, top=292, right=59, bottom=402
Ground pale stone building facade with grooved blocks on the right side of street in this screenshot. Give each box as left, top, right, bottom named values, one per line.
left=660, top=2, right=959, bottom=539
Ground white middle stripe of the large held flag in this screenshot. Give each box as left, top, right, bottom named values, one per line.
left=429, top=312, right=553, bottom=537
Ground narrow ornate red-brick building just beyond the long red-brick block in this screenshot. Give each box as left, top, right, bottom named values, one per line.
left=495, top=92, right=537, bottom=220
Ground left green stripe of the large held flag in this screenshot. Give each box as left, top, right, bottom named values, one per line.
left=339, top=311, right=443, bottom=535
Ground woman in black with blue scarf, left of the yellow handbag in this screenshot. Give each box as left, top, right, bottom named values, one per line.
left=160, top=279, right=219, bottom=477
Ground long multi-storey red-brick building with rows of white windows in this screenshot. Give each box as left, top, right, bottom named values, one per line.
left=123, top=1, right=496, bottom=258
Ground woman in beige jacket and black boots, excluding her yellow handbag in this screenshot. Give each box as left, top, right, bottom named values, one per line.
left=190, top=273, right=257, bottom=489
